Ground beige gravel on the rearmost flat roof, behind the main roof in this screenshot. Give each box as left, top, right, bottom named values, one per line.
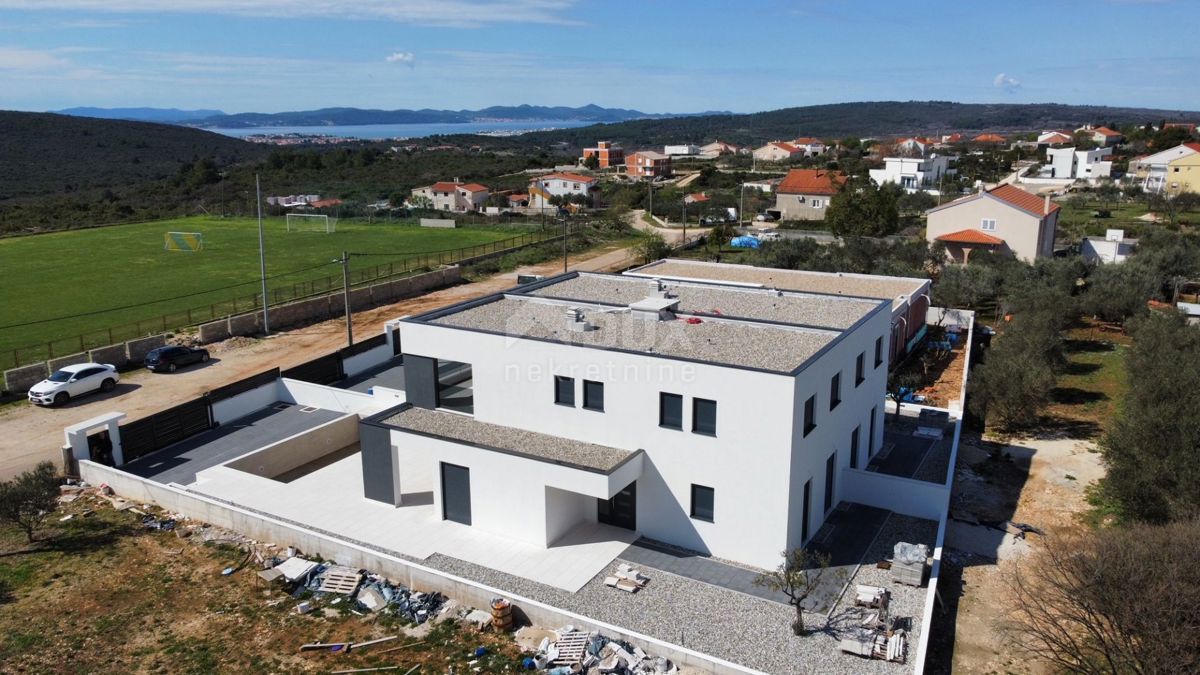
left=635, top=259, right=926, bottom=300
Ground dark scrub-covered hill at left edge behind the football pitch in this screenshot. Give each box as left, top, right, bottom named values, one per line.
left=0, top=110, right=269, bottom=196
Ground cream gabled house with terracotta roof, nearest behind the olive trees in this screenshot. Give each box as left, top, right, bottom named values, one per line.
left=925, top=185, right=1058, bottom=264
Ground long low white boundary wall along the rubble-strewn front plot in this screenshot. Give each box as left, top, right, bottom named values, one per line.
left=79, top=460, right=758, bottom=675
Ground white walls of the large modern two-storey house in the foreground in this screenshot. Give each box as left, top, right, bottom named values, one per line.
left=391, top=275, right=892, bottom=567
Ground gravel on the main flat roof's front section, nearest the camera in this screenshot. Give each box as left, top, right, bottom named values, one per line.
left=432, top=297, right=839, bottom=374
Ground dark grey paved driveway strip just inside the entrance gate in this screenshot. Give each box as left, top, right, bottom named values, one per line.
left=121, top=404, right=344, bottom=485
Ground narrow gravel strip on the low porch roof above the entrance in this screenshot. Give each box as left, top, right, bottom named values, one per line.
left=383, top=406, right=632, bottom=472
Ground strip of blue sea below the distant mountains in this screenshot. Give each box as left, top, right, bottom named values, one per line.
left=208, top=120, right=596, bottom=141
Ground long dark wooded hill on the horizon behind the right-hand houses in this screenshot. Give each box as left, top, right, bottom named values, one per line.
left=522, top=101, right=1200, bottom=147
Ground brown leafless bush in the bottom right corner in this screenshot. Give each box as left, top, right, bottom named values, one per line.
left=1008, top=520, right=1200, bottom=675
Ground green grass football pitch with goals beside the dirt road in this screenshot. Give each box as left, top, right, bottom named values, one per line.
left=0, top=217, right=536, bottom=368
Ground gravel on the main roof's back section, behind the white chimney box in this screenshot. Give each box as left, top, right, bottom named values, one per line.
left=530, top=274, right=878, bottom=329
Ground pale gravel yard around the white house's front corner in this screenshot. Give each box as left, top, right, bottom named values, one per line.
left=422, top=514, right=937, bottom=675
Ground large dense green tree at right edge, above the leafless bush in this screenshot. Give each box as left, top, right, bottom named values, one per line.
left=1099, top=312, right=1200, bottom=522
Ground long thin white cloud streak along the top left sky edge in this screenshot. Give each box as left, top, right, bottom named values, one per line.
left=0, top=0, right=577, bottom=28
